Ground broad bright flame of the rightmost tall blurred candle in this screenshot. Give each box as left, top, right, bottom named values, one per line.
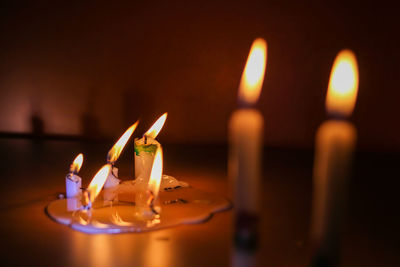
left=326, top=50, right=358, bottom=116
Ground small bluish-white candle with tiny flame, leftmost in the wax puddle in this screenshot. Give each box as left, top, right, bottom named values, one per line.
left=65, top=154, right=83, bottom=198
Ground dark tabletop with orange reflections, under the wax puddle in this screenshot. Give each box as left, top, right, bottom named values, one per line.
left=0, top=138, right=400, bottom=267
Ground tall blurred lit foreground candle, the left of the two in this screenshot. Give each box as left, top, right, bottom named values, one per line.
left=228, top=38, right=267, bottom=247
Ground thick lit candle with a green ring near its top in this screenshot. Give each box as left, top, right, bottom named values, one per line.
left=135, top=113, right=167, bottom=210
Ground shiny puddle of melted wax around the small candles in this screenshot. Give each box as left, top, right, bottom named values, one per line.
left=46, top=176, right=231, bottom=234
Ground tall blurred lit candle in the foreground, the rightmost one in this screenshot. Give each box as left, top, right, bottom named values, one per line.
left=311, top=50, right=358, bottom=266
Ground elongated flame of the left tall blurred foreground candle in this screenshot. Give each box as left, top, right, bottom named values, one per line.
left=239, top=38, right=267, bottom=104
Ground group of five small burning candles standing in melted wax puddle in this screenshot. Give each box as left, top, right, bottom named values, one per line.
left=65, top=113, right=167, bottom=218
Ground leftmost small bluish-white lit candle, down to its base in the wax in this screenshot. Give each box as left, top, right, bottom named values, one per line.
left=65, top=154, right=83, bottom=210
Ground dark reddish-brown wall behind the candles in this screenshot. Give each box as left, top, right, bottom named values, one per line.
left=0, top=1, right=400, bottom=151
